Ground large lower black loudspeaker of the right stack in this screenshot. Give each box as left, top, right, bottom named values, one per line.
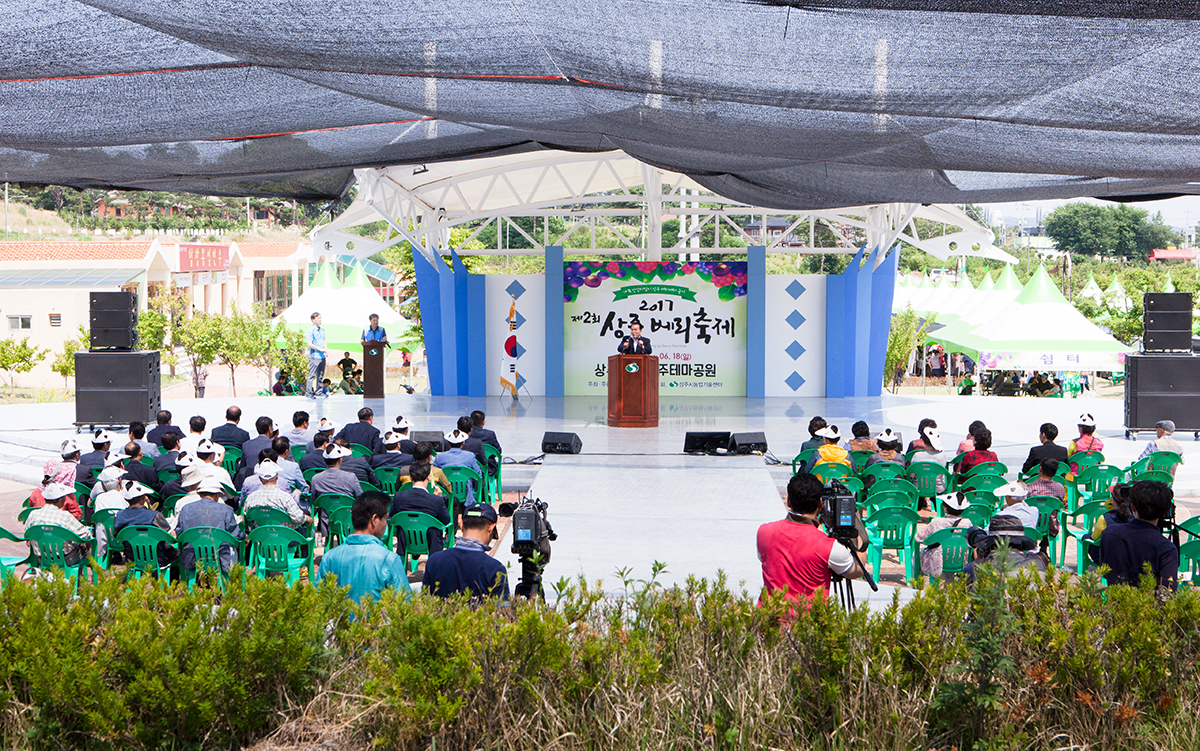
left=1124, top=355, right=1200, bottom=431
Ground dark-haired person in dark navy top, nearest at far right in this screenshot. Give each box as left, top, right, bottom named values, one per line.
left=1100, top=480, right=1180, bottom=590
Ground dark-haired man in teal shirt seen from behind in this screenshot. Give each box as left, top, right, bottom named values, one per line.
left=317, top=491, right=413, bottom=601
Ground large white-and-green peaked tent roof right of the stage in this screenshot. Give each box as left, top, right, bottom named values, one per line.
left=926, top=266, right=1130, bottom=371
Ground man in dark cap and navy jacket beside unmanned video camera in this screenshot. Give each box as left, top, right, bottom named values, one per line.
left=421, top=504, right=510, bottom=602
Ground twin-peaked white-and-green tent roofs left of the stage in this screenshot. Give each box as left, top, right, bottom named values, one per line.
left=278, top=263, right=412, bottom=353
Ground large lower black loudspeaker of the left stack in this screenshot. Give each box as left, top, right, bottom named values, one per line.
left=76, top=350, right=162, bottom=426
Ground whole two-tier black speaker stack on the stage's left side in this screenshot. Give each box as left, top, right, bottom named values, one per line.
left=74, top=292, right=162, bottom=426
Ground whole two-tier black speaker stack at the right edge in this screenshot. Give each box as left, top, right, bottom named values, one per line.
left=1124, top=293, right=1200, bottom=438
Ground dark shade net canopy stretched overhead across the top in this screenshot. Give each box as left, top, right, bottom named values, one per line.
left=7, top=0, right=1200, bottom=209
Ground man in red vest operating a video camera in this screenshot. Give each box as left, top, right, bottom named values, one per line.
left=758, top=474, right=863, bottom=602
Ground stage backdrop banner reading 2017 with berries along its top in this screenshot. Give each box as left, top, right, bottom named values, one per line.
left=563, top=260, right=746, bottom=396
